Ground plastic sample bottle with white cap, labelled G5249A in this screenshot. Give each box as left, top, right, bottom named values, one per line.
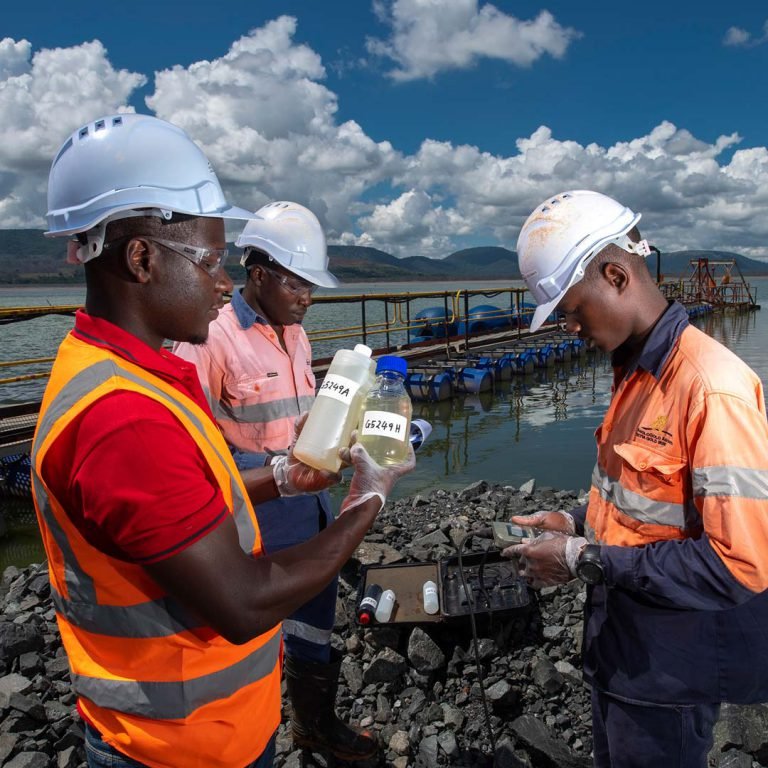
left=293, top=344, right=372, bottom=472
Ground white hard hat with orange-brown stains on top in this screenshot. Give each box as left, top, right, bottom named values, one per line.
left=517, top=189, right=650, bottom=331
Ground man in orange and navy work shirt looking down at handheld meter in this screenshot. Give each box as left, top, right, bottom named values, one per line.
left=504, top=190, right=768, bottom=768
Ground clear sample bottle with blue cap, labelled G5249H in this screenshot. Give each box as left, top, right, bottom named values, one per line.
left=357, top=355, right=413, bottom=466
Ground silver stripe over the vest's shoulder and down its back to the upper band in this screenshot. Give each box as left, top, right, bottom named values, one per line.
left=32, top=360, right=256, bottom=637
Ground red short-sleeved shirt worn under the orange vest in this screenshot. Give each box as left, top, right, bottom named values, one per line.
left=42, top=311, right=228, bottom=564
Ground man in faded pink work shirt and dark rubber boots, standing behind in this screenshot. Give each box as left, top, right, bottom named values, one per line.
left=173, top=201, right=376, bottom=760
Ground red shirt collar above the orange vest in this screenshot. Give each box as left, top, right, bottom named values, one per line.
left=72, top=309, right=208, bottom=412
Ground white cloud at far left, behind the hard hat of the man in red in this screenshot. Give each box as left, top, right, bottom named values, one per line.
left=0, top=38, right=146, bottom=227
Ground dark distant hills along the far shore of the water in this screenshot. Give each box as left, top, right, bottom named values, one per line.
left=0, top=229, right=768, bottom=284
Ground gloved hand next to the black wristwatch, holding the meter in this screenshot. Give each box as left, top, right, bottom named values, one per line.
left=501, top=531, right=587, bottom=589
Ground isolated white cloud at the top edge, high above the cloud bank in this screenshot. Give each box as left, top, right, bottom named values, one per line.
left=367, top=0, right=580, bottom=81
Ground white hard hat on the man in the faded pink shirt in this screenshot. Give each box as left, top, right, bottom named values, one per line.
left=235, top=200, right=339, bottom=288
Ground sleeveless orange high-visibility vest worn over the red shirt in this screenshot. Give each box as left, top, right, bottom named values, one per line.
left=32, top=334, right=280, bottom=768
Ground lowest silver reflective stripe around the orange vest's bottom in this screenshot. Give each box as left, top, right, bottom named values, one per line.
left=72, top=632, right=280, bottom=725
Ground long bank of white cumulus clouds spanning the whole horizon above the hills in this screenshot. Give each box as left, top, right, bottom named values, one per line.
left=0, top=16, right=768, bottom=257
